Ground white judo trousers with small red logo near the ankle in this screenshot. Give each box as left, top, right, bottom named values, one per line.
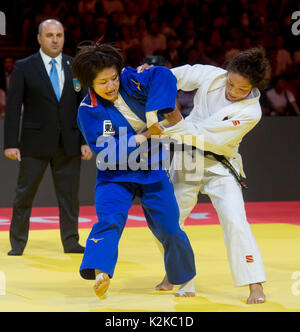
left=170, top=151, right=266, bottom=286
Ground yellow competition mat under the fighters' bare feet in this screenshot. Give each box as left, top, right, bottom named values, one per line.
left=0, top=224, right=300, bottom=312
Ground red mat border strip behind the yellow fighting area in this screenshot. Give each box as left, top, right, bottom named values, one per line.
left=0, top=201, right=300, bottom=231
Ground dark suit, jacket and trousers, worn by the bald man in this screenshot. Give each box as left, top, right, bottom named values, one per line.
left=4, top=52, right=86, bottom=251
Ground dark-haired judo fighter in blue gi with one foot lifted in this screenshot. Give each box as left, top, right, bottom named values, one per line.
left=72, top=44, right=196, bottom=297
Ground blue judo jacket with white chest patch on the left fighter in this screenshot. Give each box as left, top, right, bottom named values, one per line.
left=77, top=66, right=177, bottom=184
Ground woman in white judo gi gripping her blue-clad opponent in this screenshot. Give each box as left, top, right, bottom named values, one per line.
left=157, top=48, right=268, bottom=304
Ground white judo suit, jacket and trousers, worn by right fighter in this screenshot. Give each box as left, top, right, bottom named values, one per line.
left=159, top=65, right=266, bottom=286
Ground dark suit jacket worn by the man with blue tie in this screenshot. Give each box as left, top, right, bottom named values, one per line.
left=4, top=52, right=86, bottom=157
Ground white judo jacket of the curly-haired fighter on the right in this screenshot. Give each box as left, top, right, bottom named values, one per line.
left=164, top=64, right=262, bottom=177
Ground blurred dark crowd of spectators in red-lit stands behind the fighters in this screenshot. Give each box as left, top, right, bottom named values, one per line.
left=0, top=0, right=300, bottom=116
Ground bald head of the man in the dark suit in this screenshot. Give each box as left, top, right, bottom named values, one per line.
left=37, top=19, right=65, bottom=58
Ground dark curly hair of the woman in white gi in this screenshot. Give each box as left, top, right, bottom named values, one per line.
left=226, top=47, right=270, bottom=89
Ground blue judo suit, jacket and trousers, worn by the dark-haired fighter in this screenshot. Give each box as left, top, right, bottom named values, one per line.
left=77, top=67, right=196, bottom=285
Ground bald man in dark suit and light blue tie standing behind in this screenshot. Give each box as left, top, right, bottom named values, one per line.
left=4, top=19, right=92, bottom=255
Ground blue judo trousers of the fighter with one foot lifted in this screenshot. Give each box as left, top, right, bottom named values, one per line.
left=80, top=174, right=196, bottom=285
